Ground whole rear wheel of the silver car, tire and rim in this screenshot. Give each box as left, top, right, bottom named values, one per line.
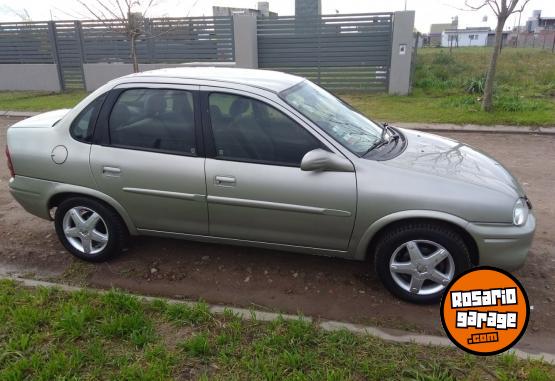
left=54, top=197, right=127, bottom=262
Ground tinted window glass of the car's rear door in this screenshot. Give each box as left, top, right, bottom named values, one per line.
left=109, top=89, right=196, bottom=154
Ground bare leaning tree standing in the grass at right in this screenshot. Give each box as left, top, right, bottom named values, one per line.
left=465, top=0, right=530, bottom=112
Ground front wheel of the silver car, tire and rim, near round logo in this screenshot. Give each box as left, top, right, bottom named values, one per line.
left=375, top=223, right=471, bottom=303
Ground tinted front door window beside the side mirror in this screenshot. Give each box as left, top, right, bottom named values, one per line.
left=209, top=93, right=322, bottom=166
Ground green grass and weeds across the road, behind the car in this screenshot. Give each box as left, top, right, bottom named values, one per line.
left=0, top=48, right=555, bottom=126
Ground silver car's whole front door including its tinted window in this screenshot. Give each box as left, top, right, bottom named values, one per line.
left=202, top=88, right=356, bottom=251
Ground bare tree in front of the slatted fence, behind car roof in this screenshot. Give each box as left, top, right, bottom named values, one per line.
left=77, top=0, right=157, bottom=73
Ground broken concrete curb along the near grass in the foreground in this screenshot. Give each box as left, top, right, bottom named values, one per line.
left=4, top=276, right=555, bottom=364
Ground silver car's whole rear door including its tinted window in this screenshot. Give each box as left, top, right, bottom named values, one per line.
left=90, top=85, right=208, bottom=235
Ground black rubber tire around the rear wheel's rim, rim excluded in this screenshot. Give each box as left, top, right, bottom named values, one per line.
left=54, top=197, right=128, bottom=262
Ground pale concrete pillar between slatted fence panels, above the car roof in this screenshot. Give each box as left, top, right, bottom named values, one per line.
left=233, top=15, right=258, bottom=69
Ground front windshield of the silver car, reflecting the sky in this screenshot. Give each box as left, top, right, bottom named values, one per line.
left=281, top=81, right=382, bottom=156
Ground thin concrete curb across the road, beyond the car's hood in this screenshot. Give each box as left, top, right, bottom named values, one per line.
left=391, top=123, right=555, bottom=135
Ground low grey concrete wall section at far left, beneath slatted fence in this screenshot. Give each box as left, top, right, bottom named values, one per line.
left=0, top=64, right=60, bottom=91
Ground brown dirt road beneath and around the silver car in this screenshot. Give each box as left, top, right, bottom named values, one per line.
left=0, top=117, right=555, bottom=353
